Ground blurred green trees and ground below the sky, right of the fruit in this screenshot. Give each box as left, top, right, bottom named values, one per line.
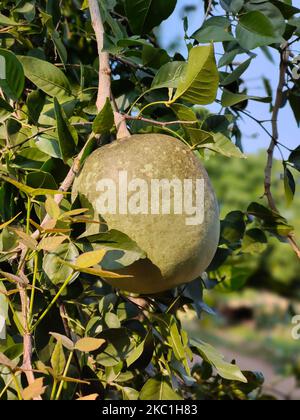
left=183, top=151, right=300, bottom=399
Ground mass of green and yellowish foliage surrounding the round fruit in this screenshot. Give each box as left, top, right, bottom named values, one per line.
left=0, top=0, right=300, bottom=400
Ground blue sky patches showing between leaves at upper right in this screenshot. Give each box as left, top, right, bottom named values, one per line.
left=160, top=0, right=300, bottom=158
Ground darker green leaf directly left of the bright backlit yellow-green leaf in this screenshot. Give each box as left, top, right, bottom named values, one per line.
left=151, top=61, right=187, bottom=89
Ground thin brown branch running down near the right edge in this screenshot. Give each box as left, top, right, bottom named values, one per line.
left=265, top=43, right=300, bottom=258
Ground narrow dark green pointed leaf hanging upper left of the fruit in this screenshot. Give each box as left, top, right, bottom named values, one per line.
left=54, top=98, right=78, bottom=162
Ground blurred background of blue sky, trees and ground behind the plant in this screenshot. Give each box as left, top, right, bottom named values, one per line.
left=157, top=0, right=300, bottom=399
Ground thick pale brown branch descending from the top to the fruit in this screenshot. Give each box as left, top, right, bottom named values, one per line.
left=89, top=0, right=130, bottom=139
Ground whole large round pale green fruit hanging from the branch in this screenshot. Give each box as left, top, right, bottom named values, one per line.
left=73, top=134, right=220, bottom=294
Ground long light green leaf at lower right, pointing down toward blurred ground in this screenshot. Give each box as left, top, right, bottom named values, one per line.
left=191, top=339, right=248, bottom=383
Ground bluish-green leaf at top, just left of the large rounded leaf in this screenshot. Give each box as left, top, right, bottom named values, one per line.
left=192, top=16, right=234, bottom=44
